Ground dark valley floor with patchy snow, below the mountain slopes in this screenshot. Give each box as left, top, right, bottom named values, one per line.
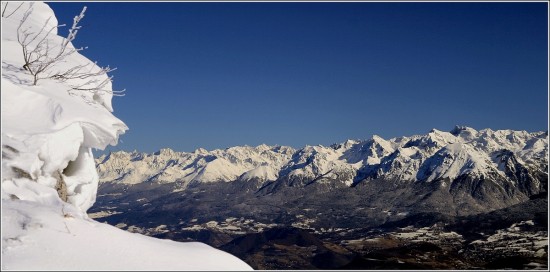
left=90, top=186, right=548, bottom=270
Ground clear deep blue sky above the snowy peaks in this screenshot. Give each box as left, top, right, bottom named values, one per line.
left=49, top=2, right=548, bottom=152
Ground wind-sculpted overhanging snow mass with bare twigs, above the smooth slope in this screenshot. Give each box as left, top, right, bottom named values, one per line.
left=2, top=3, right=127, bottom=211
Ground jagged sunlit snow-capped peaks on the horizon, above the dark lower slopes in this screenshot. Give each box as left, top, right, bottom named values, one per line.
left=96, top=126, right=548, bottom=199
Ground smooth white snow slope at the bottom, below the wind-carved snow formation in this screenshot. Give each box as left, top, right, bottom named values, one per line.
left=2, top=198, right=251, bottom=271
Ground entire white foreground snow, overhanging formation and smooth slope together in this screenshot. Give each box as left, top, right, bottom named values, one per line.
left=1, top=2, right=250, bottom=270
